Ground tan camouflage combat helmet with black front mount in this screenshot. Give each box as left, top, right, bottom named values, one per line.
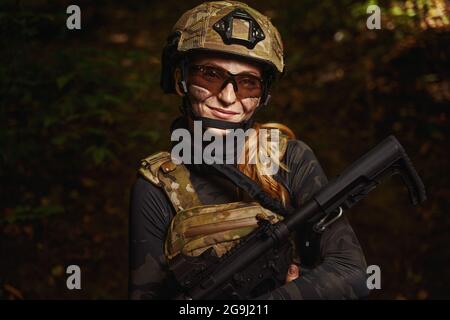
left=161, top=1, right=284, bottom=93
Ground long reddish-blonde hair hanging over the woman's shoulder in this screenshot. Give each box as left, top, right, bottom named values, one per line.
left=238, top=123, right=295, bottom=206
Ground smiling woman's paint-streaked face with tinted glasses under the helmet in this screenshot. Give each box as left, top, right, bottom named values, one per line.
left=180, top=55, right=262, bottom=131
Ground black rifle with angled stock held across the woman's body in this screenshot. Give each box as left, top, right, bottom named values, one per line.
left=169, top=136, right=426, bottom=299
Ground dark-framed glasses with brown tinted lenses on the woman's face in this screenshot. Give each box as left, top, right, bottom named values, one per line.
left=188, top=65, right=263, bottom=99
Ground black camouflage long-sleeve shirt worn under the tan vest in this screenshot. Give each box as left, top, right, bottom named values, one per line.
left=129, top=140, right=368, bottom=299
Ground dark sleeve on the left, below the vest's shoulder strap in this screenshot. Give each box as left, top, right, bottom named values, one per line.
left=129, top=177, right=173, bottom=299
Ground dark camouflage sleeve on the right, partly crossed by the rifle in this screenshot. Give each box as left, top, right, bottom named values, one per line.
left=260, top=141, right=368, bottom=299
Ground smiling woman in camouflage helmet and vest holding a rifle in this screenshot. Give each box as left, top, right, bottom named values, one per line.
left=130, top=2, right=368, bottom=299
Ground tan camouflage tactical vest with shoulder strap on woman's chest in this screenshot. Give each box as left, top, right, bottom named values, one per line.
left=139, top=129, right=288, bottom=260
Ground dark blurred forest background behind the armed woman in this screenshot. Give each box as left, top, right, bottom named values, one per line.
left=0, top=0, right=450, bottom=299
